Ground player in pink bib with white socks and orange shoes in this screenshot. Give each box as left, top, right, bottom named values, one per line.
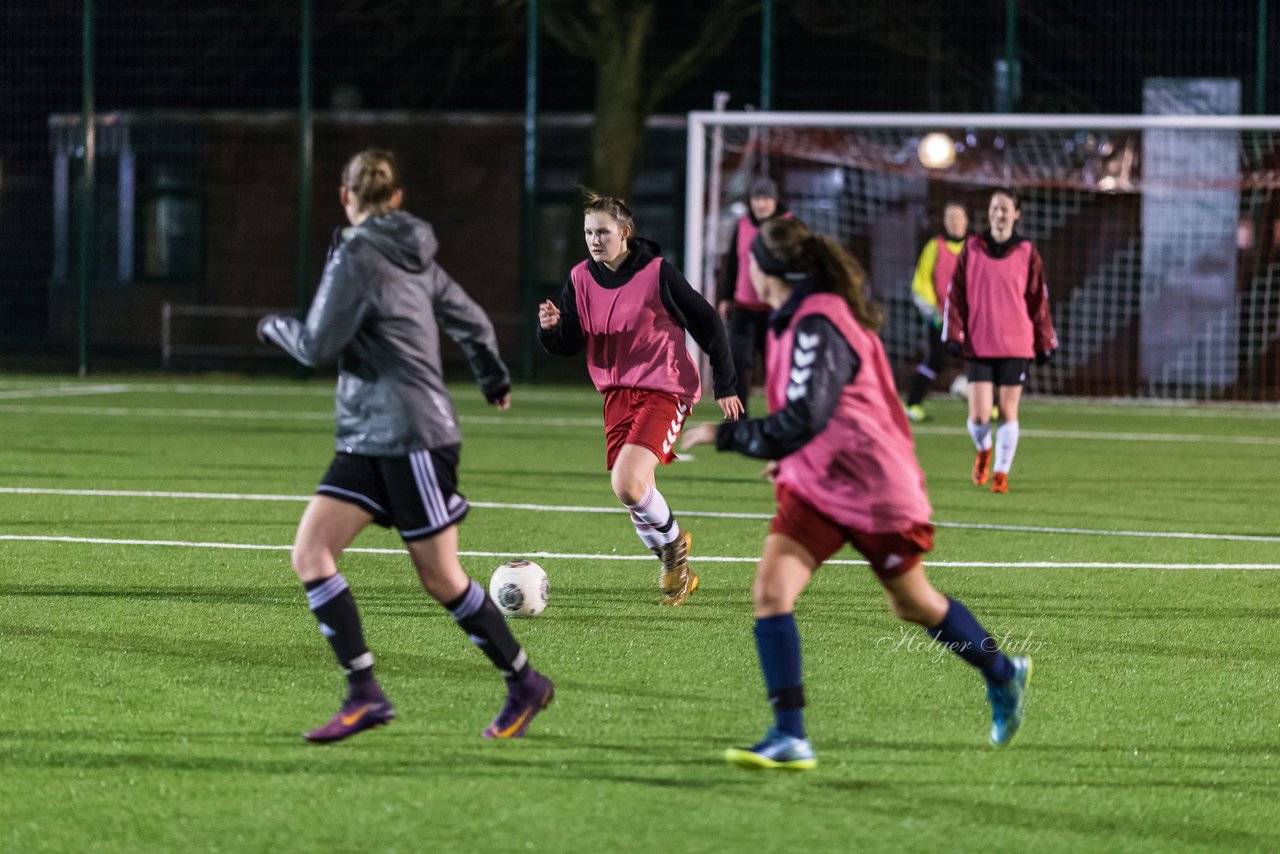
left=942, top=189, right=1057, bottom=493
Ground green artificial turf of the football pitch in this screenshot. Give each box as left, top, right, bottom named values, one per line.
left=0, top=376, right=1280, bottom=851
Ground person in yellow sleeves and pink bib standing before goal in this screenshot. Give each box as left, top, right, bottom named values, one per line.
left=906, top=201, right=969, bottom=421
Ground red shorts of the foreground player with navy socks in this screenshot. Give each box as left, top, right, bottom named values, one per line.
left=769, top=484, right=934, bottom=579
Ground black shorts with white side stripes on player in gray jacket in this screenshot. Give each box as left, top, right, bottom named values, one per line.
left=316, top=444, right=471, bottom=540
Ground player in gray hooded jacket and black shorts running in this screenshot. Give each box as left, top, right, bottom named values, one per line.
left=259, top=149, right=554, bottom=743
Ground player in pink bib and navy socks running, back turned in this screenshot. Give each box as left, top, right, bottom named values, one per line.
left=684, top=219, right=1032, bottom=769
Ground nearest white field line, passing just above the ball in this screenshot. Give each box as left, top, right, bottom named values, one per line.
left=0, top=534, right=1280, bottom=570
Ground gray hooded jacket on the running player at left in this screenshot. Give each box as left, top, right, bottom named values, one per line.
left=259, top=211, right=511, bottom=457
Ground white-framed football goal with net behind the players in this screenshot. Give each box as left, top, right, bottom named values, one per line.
left=685, top=111, right=1280, bottom=401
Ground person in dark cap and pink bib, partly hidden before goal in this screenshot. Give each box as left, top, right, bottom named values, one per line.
left=716, top=178, right=791, bottom=417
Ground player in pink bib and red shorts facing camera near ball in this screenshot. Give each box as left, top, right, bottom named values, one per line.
left=538, top=195, right=742, bottom=606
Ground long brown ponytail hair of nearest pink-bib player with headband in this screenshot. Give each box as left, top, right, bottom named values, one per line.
left=760, top=218, right=884, bottom=332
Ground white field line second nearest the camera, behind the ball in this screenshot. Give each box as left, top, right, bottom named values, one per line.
left=0, top=487, right=1280, bottom=543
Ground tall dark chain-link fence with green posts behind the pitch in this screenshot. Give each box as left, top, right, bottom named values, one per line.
left=0, top=0, right=1280, bottom=378
